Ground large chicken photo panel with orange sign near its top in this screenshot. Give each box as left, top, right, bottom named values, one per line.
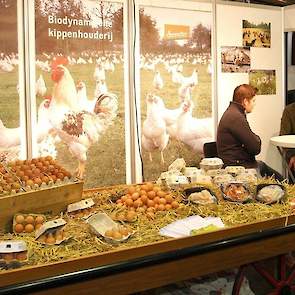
left=139, top=6, right=213, bottom=180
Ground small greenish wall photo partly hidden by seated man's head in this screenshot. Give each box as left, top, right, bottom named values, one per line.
left=249, top=70, right=276, bottom=95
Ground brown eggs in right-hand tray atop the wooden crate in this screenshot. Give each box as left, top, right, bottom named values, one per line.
left=8, top=156, right=72, bottom=187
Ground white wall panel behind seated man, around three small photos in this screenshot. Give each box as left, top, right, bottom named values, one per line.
left=216, top=2, right=284, bottom=171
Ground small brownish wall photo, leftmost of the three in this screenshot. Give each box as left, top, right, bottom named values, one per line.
left=221, top=46, right=251, bottom=73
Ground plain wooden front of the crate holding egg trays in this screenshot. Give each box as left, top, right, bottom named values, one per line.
left=0, top=181, right=83, bottom=230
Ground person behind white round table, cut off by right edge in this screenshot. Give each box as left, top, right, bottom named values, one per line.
left=280, top=102, right=295, bottom=182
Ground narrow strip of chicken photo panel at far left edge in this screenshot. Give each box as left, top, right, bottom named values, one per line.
left=0, top=0, right=23, bottom=162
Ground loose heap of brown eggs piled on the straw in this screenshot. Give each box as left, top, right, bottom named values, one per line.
left=116, top=182, right=179, bottom=212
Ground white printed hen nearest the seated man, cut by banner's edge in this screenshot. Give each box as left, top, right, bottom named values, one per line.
left=177, top=100, right=213, bottom=154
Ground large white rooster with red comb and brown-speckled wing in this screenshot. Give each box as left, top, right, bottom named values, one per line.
left=48, top=58, right=118, bottom=178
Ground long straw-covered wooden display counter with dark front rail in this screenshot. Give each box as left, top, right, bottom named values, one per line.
left=0, top=179, right=295, bottom=294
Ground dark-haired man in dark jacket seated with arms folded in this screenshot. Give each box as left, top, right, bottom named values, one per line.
left=216, top=84, right=284, bottom=181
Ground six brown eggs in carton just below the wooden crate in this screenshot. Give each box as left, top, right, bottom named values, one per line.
left=13, top=214, right=45, bottom=234
